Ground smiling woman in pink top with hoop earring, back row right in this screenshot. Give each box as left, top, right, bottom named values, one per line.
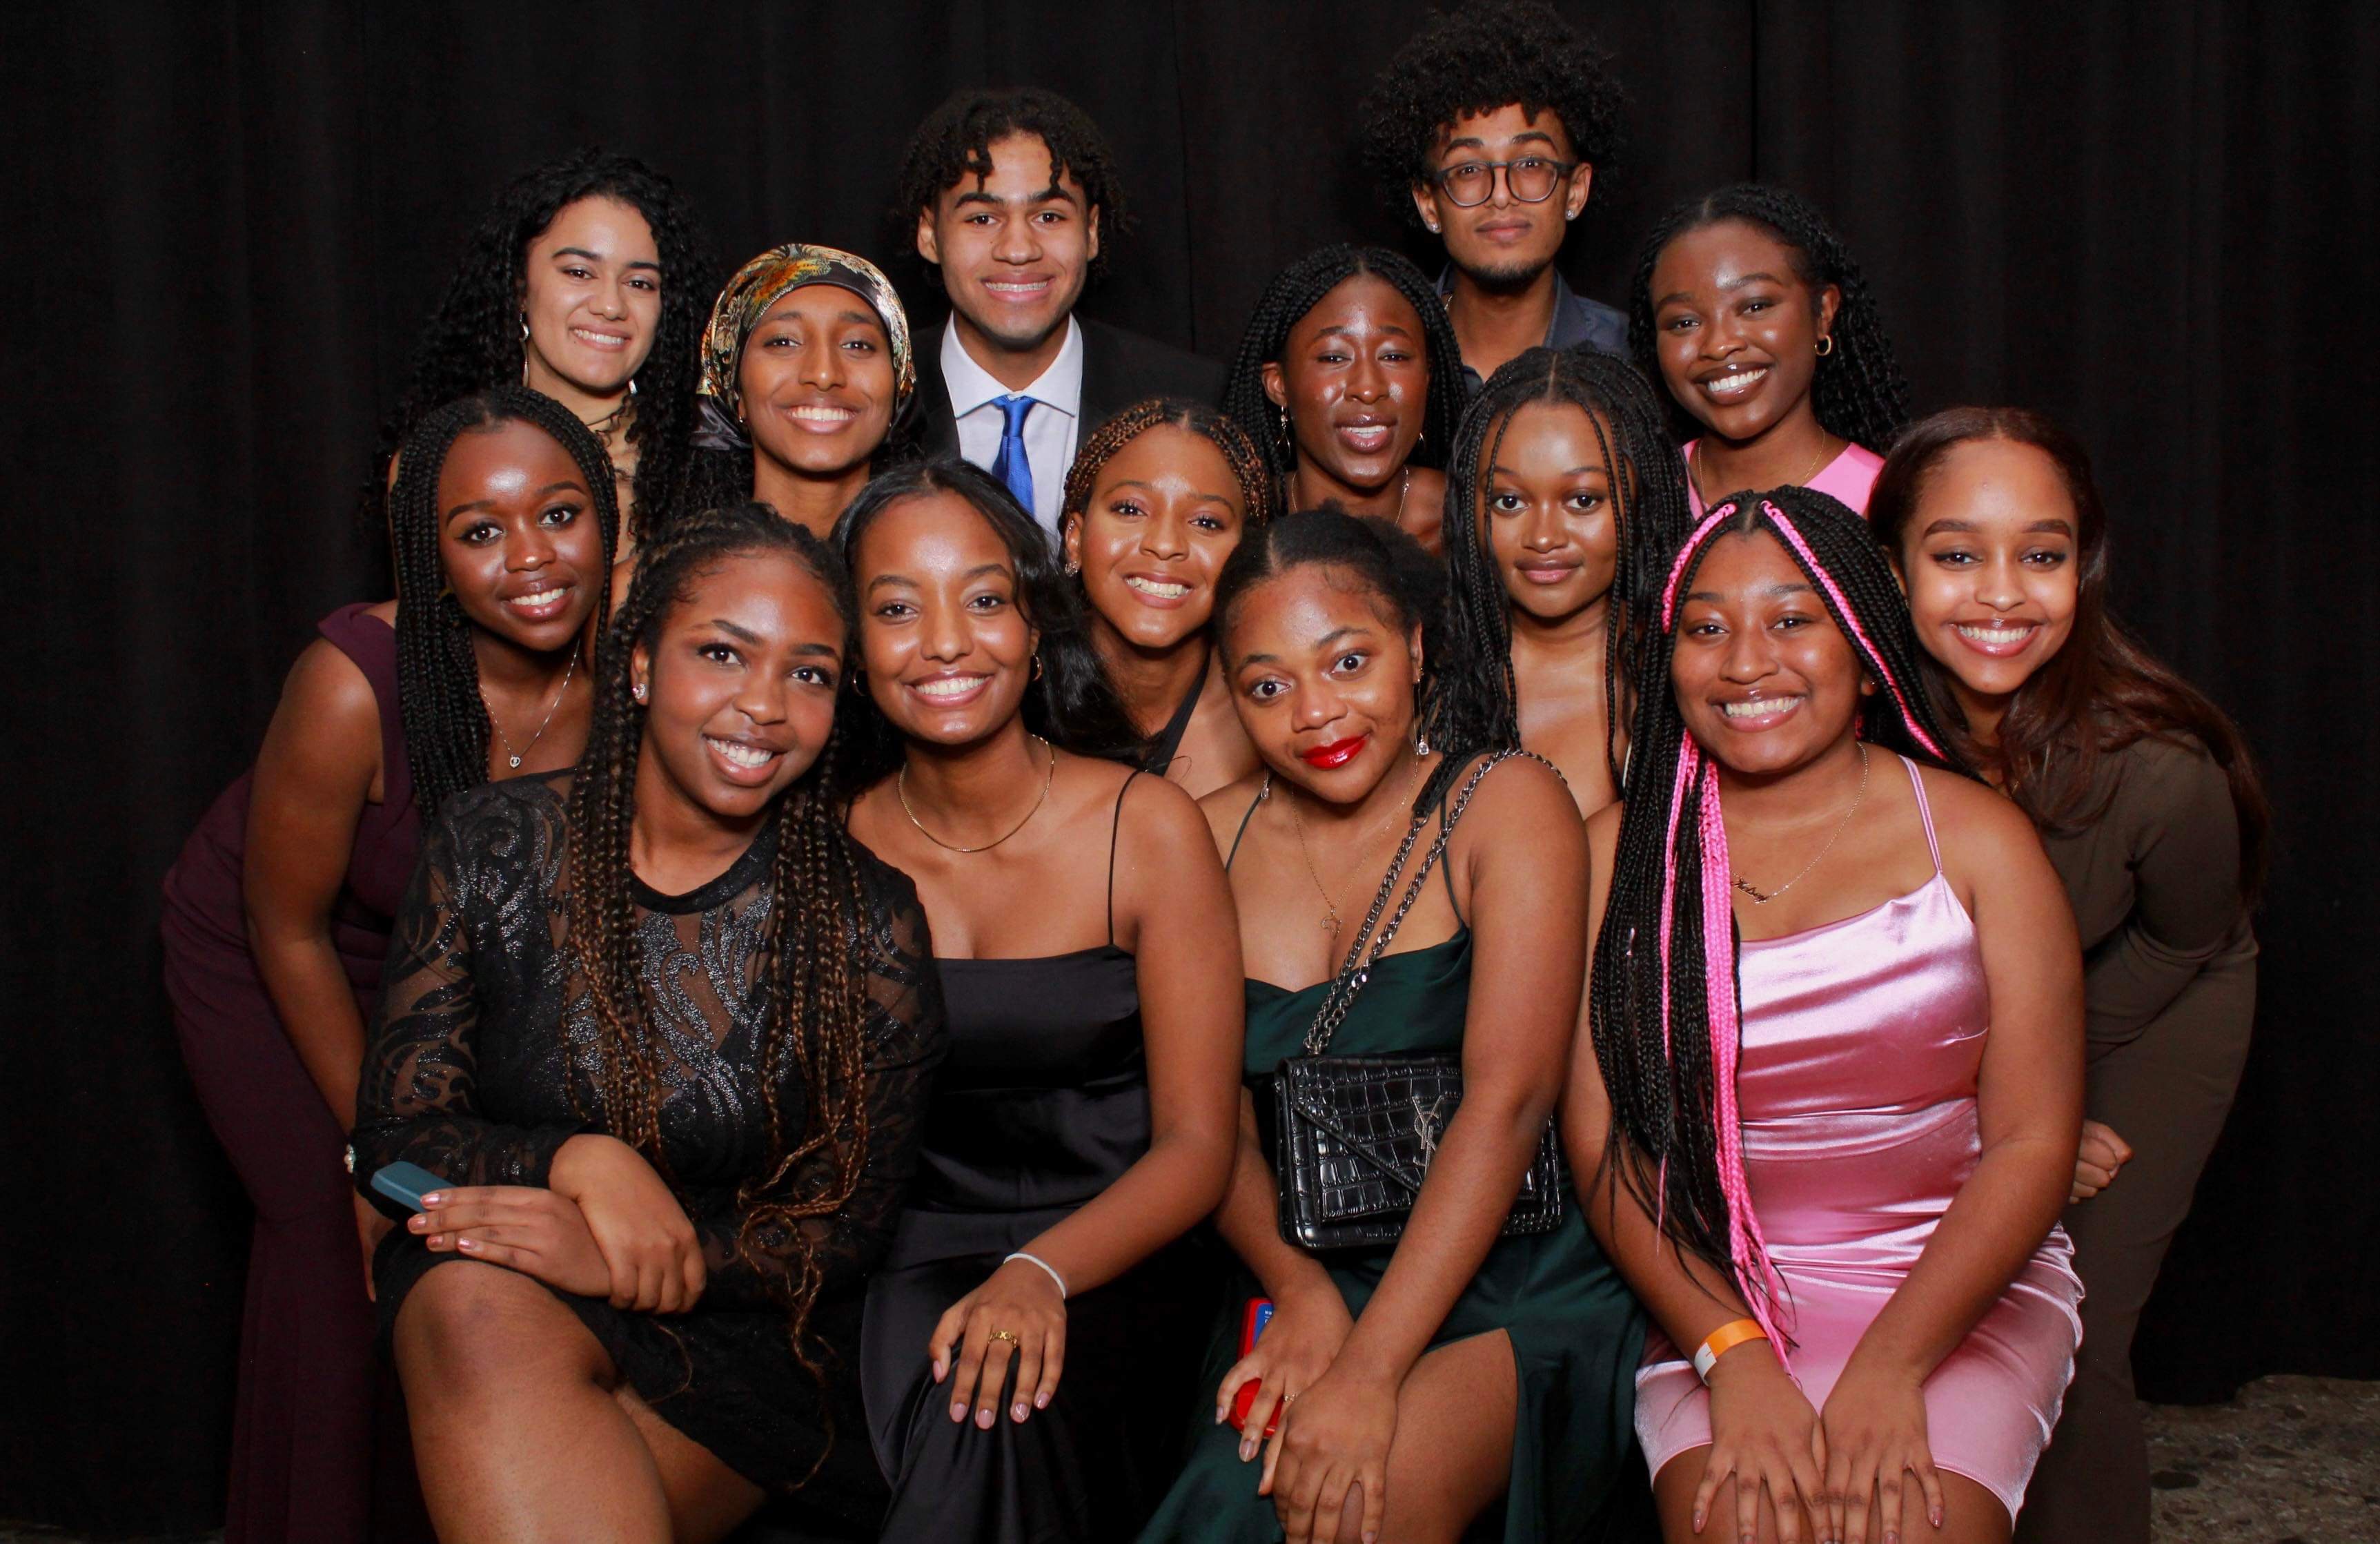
left=1628, top=183, right=1909, bottom=518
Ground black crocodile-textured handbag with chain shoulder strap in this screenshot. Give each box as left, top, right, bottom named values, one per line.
left=1273, top=752, right=1568, bottom=1249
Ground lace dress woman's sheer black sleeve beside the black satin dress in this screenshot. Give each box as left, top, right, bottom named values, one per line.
left=693, top=850, right=945, bottom=1309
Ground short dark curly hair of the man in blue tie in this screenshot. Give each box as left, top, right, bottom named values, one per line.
left=887, top=86, right=1130, bottom=283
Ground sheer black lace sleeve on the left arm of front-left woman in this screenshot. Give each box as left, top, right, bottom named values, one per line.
left=355, top=785, right=583, bottom=1215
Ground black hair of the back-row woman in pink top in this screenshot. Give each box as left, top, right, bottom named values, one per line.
left=1628, top=183, right=1909, bottom=454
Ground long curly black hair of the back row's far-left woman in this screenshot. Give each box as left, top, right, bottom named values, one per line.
left=362, top=148, right=719, bottom=547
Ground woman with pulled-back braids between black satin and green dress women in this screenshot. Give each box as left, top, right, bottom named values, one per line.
left=1059, top=398, right=1273, bottom=799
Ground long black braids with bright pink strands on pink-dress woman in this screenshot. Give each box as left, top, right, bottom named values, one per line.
left=1587, top=488, right=1973, bottom=1354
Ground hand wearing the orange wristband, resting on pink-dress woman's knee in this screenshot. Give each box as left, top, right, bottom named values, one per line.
left=1695, top=1340, right=1838, bottom=1544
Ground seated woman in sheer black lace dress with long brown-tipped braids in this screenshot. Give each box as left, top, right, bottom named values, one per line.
left=355, top=505, right=943, bottom=1539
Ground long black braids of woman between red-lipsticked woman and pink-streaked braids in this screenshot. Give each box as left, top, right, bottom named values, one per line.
left=1430, top=347, right=1690, bottom=788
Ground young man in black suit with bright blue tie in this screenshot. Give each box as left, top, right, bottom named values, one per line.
left=897, top=88, right=1223, bottom=536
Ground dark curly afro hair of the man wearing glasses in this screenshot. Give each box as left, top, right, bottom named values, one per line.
left=1357, top=0, right=1628, bottom=226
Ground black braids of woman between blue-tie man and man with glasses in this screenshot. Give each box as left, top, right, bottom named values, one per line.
left=1223, top=243, right=1464, bottom=483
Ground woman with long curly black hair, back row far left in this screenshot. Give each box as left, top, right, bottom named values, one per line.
left=366, top=148, right=711, bottom=547
